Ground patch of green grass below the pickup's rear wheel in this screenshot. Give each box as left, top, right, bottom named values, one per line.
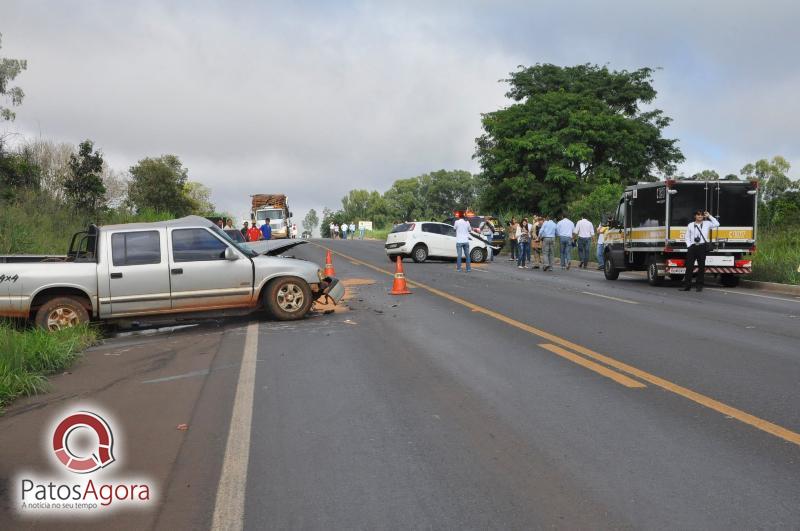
left=0, top=323, right=98, bottom=409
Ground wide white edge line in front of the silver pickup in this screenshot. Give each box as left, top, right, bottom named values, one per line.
left=211, top=322, right=258, bottom=530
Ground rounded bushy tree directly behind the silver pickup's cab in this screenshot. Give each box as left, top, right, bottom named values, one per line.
left=128, top=155, right=192, bottom=217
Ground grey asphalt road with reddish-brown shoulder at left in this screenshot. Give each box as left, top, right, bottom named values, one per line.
left=0, top=240, right=800, bottom=529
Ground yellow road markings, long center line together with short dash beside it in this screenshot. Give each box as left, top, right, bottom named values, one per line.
left=315, top=244, right=800, bottom=446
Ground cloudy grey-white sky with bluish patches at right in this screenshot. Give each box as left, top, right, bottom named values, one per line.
left=0, top=0, right=800, bottom=227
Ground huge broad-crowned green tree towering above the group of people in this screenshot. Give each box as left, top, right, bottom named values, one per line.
left=475, top=64, right=684, bottom=213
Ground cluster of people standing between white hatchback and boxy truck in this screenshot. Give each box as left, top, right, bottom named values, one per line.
left=508, top=215, right=608, bottom=271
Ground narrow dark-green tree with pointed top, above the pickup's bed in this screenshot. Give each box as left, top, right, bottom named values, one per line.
left=64, top=140, right=106, bottom=216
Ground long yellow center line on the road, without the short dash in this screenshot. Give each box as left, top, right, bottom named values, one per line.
left=314, top=243, right=800, bottom=446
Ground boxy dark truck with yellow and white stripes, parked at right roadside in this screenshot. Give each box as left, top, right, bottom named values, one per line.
left=604, top=180, right=758, bottom=287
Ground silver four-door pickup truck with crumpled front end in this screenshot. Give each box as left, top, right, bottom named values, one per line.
left=0, top=216, right=344, bottom=330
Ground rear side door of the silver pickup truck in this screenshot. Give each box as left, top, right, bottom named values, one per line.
left=105, top=229, right=171, bottom=317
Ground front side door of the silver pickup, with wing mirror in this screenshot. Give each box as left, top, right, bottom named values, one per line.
left=168, top=227, right=253, bottom=311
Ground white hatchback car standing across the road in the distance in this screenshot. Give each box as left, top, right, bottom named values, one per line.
left=384, top=221, right=489, bottom=262
